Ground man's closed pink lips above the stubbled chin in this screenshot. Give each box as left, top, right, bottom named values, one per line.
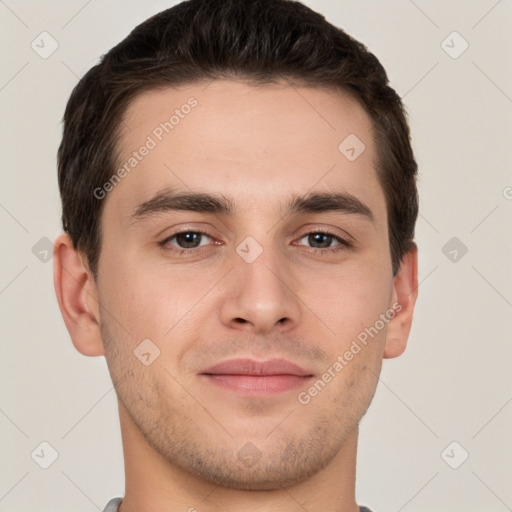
left=200, top=359, right=314, bottom=395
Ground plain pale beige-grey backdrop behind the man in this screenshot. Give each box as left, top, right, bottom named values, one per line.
left=0, top=0, right=512, bottom=512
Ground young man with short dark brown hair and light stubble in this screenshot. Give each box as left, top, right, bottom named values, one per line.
left=54, top=0, right=418, bottom=512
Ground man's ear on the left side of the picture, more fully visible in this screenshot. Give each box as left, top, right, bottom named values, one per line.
left=53, top=234, right=104, bottom=356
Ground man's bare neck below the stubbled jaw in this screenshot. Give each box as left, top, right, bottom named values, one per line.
left=119, top=403, right=359, bottom=512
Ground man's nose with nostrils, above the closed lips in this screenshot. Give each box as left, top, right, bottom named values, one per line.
left=220, top=245, right=300, bottom=335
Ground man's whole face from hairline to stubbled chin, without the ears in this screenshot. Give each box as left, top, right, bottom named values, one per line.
left=97, top=80, right=396, bottom=489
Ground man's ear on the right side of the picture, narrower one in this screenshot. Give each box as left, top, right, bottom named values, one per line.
left=384, top=244, right=418, bottom=358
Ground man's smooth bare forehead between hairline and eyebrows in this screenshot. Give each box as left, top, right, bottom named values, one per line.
left=106, top=80, right=385, bottom=222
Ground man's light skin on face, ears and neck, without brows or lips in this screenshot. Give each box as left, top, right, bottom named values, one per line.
left=54, top=80, right=417, bottom=512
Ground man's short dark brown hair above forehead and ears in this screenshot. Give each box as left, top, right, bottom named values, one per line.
left=58, top=0, right=418, bottom=278
